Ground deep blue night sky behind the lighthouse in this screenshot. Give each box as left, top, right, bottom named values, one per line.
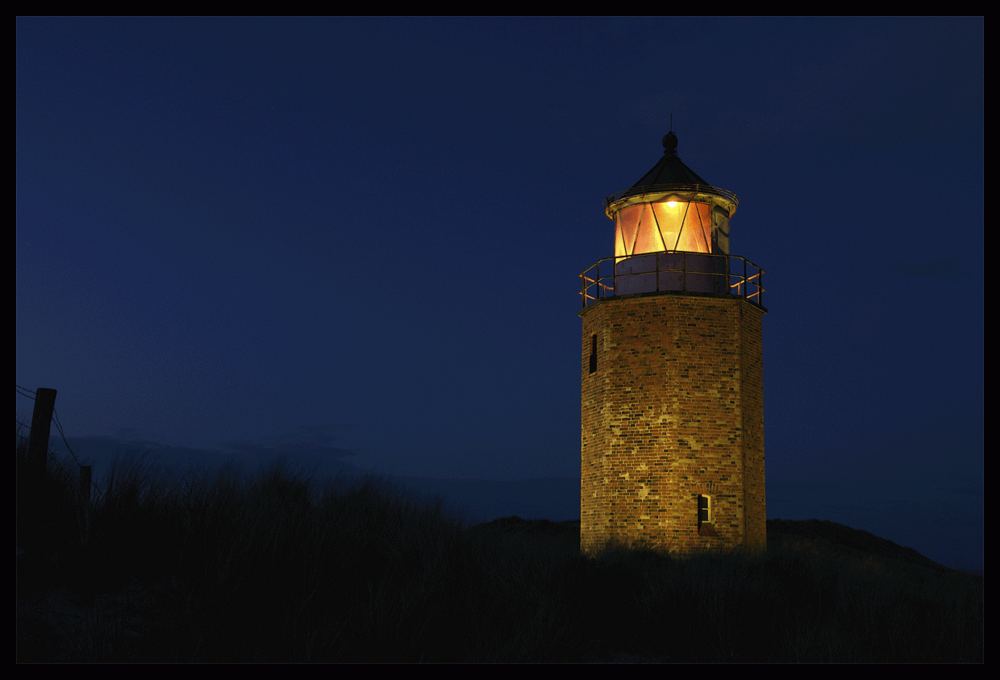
left=15, top=18, right=984, bottom=567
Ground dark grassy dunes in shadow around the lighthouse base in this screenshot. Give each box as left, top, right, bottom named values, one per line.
left=16, top=446, right=983, bottom=661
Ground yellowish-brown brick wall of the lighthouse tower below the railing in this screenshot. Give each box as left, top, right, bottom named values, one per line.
left=580, top=294, right=767, bottom=553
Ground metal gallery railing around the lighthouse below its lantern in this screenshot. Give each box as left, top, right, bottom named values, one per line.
left=579, top=251, right=765, bottom=308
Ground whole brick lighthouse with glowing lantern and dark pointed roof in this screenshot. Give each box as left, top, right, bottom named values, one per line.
left=580, top=131, right=767, bottom=553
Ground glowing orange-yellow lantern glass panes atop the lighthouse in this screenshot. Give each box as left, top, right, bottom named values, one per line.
left=615, top=200, right=712, bottom=257
